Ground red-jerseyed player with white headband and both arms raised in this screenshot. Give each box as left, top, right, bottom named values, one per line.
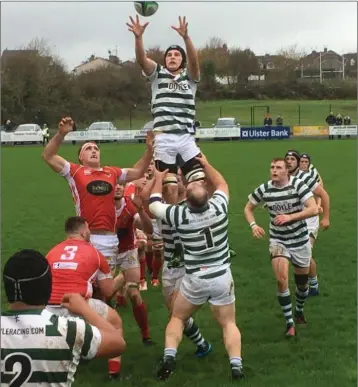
left=42, top=117, right=153, bottom=268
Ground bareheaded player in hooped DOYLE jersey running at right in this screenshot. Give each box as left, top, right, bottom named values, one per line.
left=244, top=158, right=318, bottom=338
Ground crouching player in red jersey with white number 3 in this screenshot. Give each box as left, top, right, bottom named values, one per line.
left=46, top=216, right=122, bottom=378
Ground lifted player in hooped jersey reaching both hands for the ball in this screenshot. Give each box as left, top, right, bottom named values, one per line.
left=127, top=16, right=204, bottom=204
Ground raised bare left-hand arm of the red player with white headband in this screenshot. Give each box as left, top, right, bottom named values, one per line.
left=42, top=117, right=74, bottom=173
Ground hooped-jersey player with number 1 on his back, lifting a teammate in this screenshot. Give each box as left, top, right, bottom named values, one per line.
left=149, top=157, right=244, bottom=380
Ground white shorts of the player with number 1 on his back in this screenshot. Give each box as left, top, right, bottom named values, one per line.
left=180, top=269, right=235, bottom=306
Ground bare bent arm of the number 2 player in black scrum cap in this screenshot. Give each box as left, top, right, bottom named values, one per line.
left=62, top=294, right=126, bottom=358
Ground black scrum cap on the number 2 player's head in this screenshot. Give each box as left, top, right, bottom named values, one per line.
left=3, top=249, right=52, bottom=306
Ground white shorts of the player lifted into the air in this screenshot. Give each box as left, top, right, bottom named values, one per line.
left=153, top=133, right=200, bottom=165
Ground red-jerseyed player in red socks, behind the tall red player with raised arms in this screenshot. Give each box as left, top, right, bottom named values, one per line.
left=115, top=184, right=153, bottom=345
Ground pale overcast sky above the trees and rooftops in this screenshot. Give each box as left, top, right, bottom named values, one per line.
left=1, top=2, right=357, bottom=70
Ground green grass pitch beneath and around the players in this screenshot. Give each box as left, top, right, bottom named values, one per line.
left=1, top=140, right=357, bottom=387
